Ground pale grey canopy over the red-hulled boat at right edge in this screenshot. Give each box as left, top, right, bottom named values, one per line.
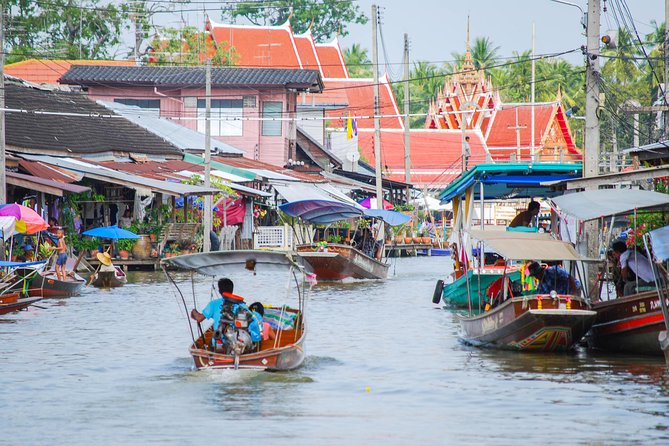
left=552, top=189, right=669, bottom=221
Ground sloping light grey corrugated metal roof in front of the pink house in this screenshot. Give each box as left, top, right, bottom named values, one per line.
left=97, top=101, right=244, bottom=155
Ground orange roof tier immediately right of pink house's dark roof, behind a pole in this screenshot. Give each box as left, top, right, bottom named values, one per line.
left=324, top=76, right=404, bottom=129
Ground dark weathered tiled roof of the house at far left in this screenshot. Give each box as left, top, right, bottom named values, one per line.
left=5, top=83, right=181, bottom=157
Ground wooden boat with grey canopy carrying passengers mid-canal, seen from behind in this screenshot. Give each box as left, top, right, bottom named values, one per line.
left=161, top=250, right=311, bottom=371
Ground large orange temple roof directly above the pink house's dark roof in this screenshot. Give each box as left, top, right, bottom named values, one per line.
left=206, top=19, right=303, bottom=68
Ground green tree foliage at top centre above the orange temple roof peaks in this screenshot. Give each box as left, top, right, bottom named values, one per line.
left=224, top=0, right=367, bottom=42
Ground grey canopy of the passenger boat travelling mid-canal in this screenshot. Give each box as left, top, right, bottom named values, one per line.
left=161, top=250, right=302, bottom=276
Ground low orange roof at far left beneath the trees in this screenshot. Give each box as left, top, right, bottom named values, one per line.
left=5, top=59, right=135, bottom=85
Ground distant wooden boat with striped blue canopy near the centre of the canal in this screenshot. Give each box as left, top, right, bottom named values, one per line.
left=279, top=200, right=411, bottom=280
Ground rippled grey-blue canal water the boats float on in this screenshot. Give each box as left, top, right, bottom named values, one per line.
left=0, top=257, right=669, bottom=445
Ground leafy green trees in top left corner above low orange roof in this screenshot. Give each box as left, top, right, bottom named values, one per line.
left=3, top=0, right=130, bottom=63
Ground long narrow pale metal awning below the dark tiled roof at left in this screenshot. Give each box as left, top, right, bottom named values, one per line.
left=21, top=154, right=220, bottom=197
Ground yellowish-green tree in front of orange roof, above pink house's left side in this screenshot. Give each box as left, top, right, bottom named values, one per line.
left=149, top=26, right=239, bottom=67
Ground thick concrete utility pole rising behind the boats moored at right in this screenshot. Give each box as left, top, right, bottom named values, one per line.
left=583, top=0, right=600, bottom=178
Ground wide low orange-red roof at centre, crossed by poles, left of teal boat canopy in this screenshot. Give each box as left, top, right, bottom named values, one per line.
left=358, top=130, right=486, bottom=186
